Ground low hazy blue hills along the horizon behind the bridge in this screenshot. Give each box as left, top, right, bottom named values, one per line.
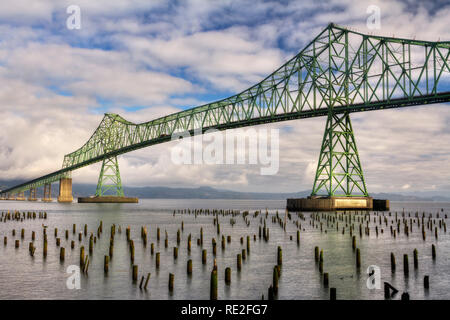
left=0, top=180, right=450, bottom=201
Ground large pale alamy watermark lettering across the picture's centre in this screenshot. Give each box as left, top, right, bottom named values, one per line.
left=171, top=128, right=280, bottom=175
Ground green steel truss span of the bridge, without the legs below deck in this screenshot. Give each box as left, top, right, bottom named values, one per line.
left=2, top=24, right=450, bottom=193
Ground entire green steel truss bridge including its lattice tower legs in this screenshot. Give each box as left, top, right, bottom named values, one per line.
left=0, top=24, right=450, bottom=199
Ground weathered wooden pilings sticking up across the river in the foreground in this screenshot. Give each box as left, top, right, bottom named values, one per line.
left=1, top=205, right=447, bottom=300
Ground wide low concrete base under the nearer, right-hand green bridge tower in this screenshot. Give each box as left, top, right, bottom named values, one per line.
left=286, top=197, right=389, bottom=211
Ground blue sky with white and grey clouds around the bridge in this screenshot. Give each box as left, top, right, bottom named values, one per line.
left=0, top=0, right=450, bottom=193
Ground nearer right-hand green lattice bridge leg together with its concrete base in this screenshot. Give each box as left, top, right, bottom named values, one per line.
left=286, top=111, right=389, bottom=211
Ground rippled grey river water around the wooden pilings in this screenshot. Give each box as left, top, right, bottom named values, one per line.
left=0, top=199, right=450, bottom=299
